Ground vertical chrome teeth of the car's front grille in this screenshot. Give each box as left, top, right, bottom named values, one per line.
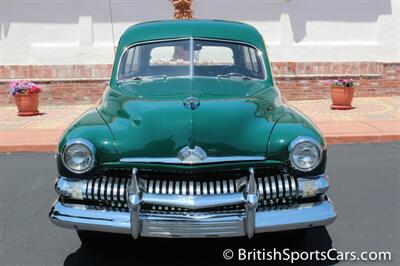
left=79, top=175, right=298, bottom=209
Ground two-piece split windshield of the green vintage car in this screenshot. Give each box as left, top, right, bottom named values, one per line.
left=118, top=40, right=265, bottom=81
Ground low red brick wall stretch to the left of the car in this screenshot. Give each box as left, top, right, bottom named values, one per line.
left=0, top=65, right=112, bottom=105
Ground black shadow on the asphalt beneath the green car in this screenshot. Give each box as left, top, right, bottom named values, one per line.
left=64, top=227, right=338, bottom=266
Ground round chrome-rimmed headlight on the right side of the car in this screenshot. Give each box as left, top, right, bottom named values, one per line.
left=289, top=137, right=322, bottom=172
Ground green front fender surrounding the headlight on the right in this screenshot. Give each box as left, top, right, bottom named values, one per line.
left=267, top=107, right=327, bottom=176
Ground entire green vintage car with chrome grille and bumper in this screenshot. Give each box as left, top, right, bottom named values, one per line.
left=50, top=20, right=336, bottom=241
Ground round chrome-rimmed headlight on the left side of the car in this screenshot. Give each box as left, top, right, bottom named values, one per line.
left=62, top=139, right=95, bottom=174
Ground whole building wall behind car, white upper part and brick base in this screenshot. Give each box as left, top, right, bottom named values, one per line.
left=0, top=0, right=400, bottom=104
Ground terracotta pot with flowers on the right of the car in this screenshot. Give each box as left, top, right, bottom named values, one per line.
left=331, top=79, right=355, bottom=110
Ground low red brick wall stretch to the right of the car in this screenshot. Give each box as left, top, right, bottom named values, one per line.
left=272, top=62, right=400, bottom=100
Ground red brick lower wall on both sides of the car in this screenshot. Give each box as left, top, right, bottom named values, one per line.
left=0, top=62, right=400, bottom=105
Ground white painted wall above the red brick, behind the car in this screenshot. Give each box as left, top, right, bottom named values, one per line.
left=0, top=0, right=400, bottom=65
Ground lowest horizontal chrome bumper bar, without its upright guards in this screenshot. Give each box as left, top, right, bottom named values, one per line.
left=50, top=200, right=337, bottom=238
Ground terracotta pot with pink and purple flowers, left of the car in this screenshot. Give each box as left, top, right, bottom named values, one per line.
left=8, top=80, right=42, bottom=116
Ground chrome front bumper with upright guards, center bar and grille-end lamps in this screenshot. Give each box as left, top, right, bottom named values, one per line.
left=49, top=169, right=337, bottom=238
